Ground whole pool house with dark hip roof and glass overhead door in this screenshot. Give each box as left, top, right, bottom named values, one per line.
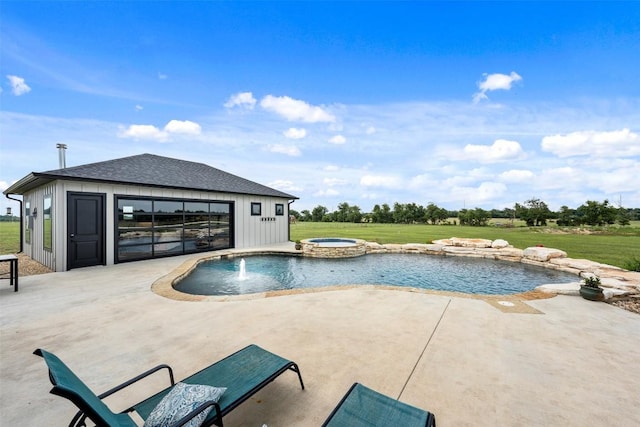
left=4, top=154, right=297, bottom=271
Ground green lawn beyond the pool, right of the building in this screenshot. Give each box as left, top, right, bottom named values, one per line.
left=291, top=222, right=640, bottom=267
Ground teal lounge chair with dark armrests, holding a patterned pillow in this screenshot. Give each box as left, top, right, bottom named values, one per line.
left=34, top=345, right=304, bottom=427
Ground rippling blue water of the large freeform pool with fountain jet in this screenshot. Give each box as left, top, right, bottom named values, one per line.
left=174, top=254, right=578, bottom=295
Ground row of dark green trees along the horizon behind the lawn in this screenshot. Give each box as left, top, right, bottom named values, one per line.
left=290, top=199, right=640, bottom=227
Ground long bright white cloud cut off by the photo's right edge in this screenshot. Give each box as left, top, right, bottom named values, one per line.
left=542, top=128, right=640, bottom=157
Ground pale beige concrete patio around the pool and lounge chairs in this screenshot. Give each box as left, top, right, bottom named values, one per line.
left=0, top=249, right=640, bottom=427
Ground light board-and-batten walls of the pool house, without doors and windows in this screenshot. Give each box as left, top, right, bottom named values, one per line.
left=23, top=180, right=290, bottom=271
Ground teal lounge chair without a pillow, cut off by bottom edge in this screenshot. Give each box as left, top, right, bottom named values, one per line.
left=322, top=383, right=436, bottom=427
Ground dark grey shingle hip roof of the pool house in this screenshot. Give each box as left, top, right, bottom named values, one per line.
left=5, top=154, right=297, bottom=199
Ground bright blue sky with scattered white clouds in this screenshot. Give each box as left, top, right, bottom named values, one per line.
left=0, top=1, right=640, bottom=213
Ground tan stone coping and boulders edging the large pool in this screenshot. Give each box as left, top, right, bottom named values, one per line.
left=151, top=237, right=640, bottom=301
